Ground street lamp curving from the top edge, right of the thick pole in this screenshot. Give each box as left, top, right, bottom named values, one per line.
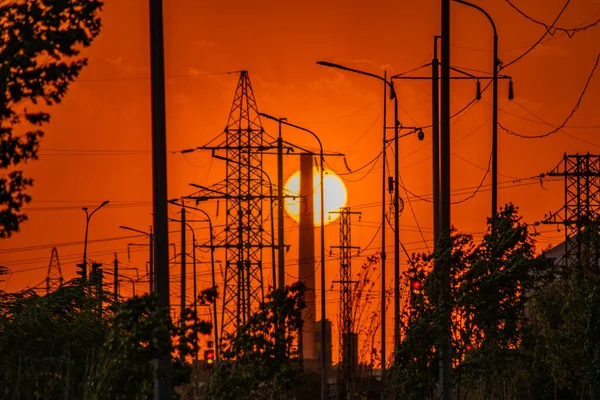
left=452, top=0, right=500, bottom=219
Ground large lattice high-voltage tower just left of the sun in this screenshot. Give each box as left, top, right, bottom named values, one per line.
left=189, top=71, right=276, bottom=346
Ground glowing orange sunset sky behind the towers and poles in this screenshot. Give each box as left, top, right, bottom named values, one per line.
left=0, top=0, right=600, bottom=362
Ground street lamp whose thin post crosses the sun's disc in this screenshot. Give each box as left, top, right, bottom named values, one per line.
left=259, top=113, right=327, bottom=399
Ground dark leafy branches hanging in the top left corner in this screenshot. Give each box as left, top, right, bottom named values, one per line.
left=0, top=0, right=102, bottom=238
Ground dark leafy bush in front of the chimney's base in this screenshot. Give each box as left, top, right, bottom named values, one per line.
left=205, top=282, right=306, bottom=400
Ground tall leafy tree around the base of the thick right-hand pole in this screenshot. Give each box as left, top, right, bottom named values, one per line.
left=388, top=204, right=548, bottom=399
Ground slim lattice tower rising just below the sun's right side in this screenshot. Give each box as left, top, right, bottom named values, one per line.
left=330, top=207, right=360, bottom=399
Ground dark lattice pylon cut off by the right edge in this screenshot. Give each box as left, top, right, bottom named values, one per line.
left=542, top=153, right=600, bottom=268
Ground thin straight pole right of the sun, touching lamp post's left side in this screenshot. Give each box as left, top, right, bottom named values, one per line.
left=381, top=71, right=387, bottom=384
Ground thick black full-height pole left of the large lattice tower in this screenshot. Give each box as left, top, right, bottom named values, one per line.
left=149, top=0, right=172, bottom=400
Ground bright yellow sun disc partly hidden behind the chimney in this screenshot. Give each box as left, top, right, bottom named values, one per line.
left=284, top=168, right=348, bottom=226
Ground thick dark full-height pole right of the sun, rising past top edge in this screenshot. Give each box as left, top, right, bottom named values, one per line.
left=438, top=0, right=452, bottom=400
